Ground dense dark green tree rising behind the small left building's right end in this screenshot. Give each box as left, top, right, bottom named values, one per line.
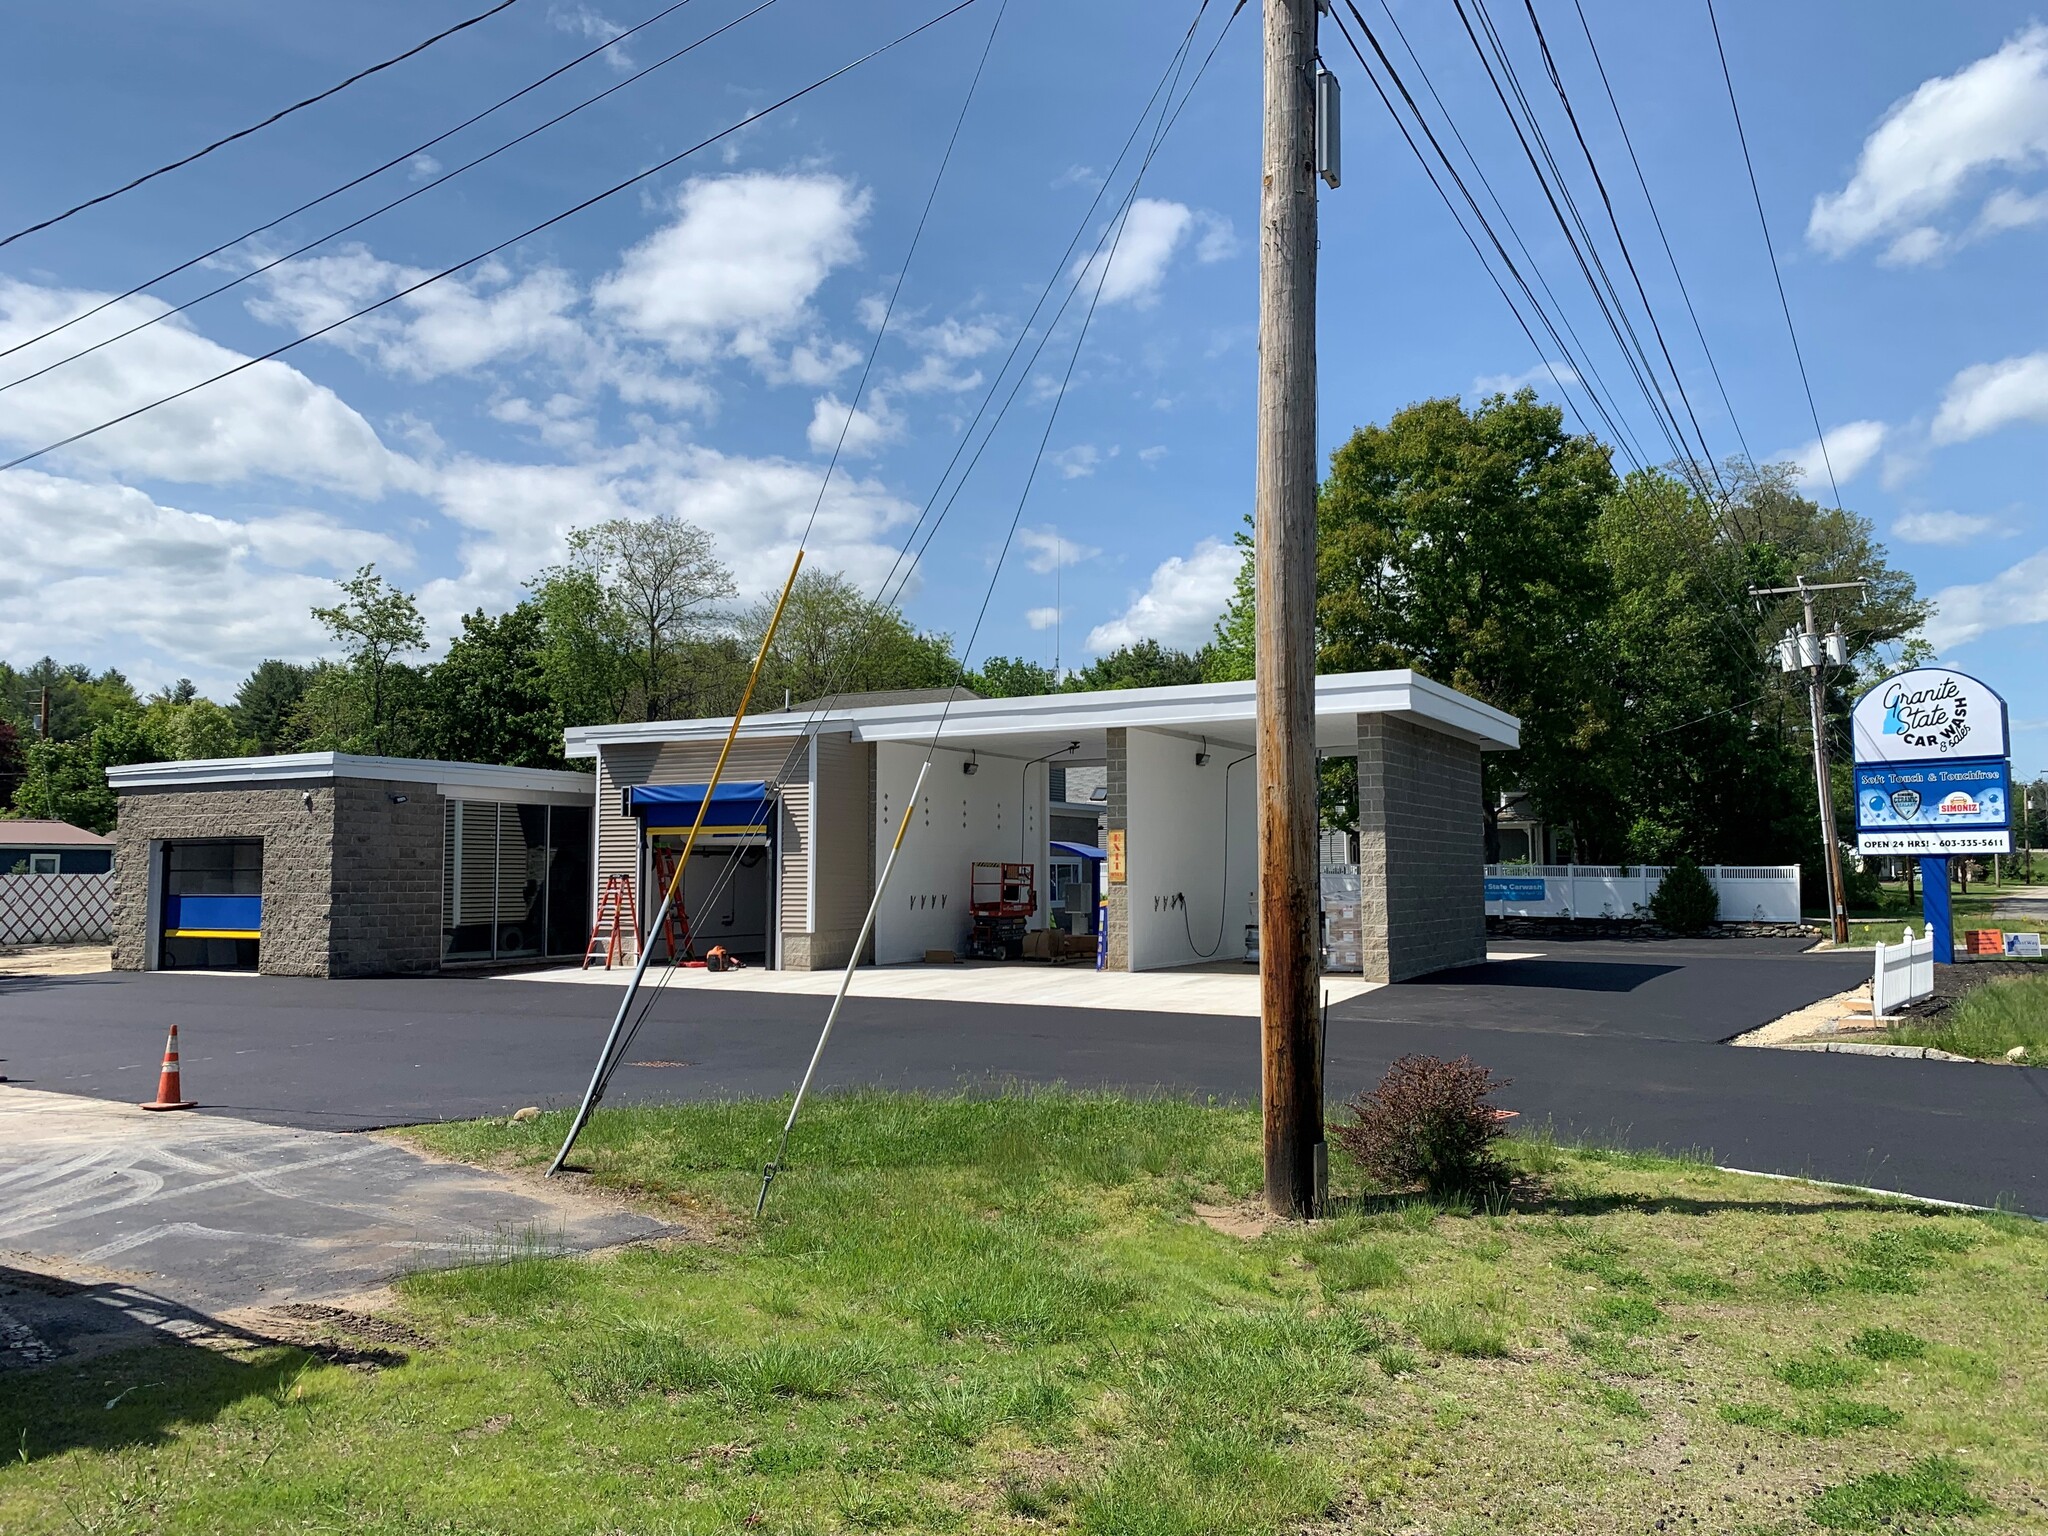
left=424, top=600, right=565, bottom=768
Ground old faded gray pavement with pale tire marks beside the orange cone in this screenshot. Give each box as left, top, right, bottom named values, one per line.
left=0, top=1087, right=664, bottom=1313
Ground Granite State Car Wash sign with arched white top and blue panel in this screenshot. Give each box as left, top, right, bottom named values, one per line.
left=1851, top=668, right=2013, bottom=856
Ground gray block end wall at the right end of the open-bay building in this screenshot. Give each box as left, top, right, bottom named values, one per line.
left=1358, top=715, right=1487, bottom=981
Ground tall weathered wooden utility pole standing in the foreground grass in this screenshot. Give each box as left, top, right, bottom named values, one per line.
left=1253, top=0, right=1323, bottom=1217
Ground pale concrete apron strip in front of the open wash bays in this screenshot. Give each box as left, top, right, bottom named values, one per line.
left=496, top=961, right=1386, bottom=1018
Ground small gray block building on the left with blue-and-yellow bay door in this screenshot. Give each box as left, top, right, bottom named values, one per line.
left=106, top=752, right=592, bottom=977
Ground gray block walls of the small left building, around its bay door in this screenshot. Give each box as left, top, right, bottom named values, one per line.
left=113, top=778, right=444, bottom=977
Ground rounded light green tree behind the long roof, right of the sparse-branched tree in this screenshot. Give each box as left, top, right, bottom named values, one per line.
left=731, top=571, right=963, bottom=705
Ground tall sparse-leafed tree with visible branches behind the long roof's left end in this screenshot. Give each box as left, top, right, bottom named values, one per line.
left=539, top=512, right=737, bottom=721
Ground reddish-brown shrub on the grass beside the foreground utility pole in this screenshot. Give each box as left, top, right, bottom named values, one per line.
left=1331, top=1057, right=1507, bottom=1200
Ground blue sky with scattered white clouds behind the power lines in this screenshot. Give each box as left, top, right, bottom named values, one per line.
left=0, top=0, right=2048, bottom=768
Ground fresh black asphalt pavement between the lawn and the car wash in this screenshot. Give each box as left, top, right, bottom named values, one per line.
left=0, top=940, right=2048, bottom=1214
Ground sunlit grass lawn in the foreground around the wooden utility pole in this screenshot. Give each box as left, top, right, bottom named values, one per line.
left=0, top=1094, right=2048, bottom=1536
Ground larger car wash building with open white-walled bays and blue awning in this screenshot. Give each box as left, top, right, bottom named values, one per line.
left=567, top=670, right=1520, bottom=979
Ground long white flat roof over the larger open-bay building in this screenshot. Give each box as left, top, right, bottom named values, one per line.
left=565, top=670, right=1522, bottom=758
